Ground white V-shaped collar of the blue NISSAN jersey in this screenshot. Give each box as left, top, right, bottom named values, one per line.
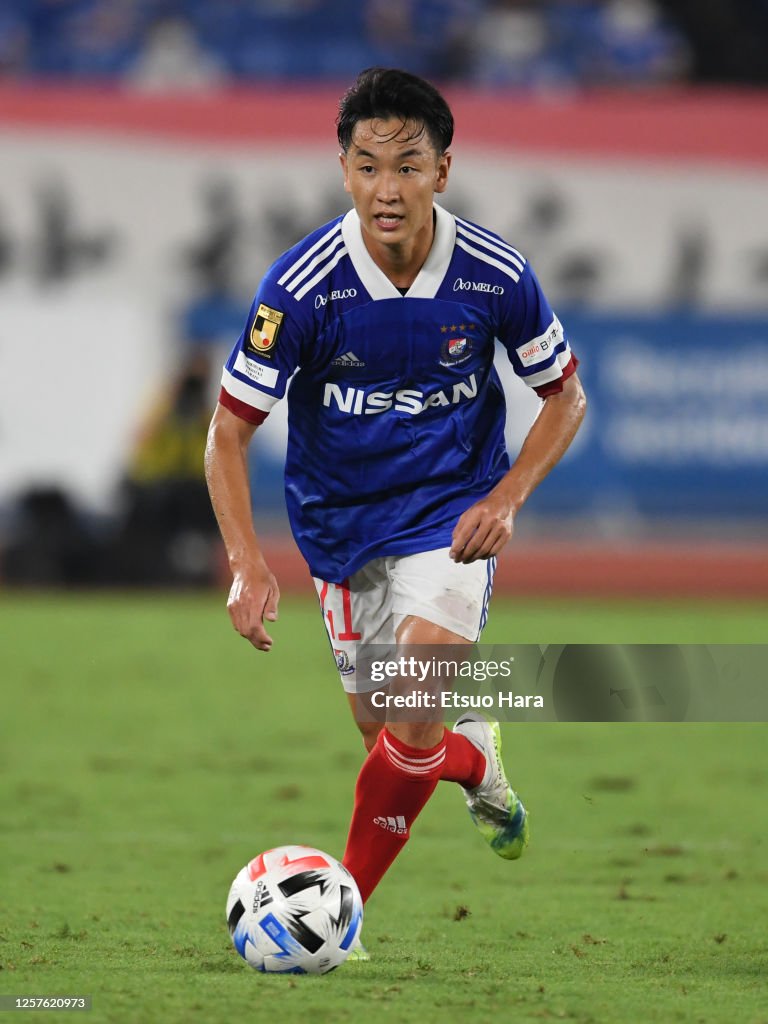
left=341, top=204, right=456, bottom=299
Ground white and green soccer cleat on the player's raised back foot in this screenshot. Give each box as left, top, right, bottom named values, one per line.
left=454, top=712, right=528, bottom=860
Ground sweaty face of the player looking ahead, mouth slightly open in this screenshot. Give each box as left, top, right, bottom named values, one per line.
left=341, top=118, right=451, bottom=257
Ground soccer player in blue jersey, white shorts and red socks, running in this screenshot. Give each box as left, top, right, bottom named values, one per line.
left=206, top=69, right=585, bottom=921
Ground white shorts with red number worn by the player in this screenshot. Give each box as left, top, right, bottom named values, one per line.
left=313, top=548, right=496, bottom=693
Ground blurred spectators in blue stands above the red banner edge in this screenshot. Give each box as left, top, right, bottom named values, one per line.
left=0, top=0, right=768, bottom=90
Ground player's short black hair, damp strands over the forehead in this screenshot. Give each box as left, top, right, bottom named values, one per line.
left=336, top=68, right=454, bottom=154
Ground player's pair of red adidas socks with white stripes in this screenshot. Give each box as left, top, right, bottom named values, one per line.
left=343, top=728, right=485, bottom=902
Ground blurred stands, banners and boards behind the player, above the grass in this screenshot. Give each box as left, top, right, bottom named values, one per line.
left=0, top=0, right=768, bottom=596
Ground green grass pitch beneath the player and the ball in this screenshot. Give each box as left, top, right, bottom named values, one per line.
left=0, top=594, right=768, bottom=1024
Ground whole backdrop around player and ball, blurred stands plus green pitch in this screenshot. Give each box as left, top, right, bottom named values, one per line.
left=0, top=0, right=768, bottom=1024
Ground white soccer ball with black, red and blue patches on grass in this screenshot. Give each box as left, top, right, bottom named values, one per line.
left=226, top=846, right=362, bottom=974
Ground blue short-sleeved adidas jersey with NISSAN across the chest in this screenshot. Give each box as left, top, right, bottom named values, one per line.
left=219, top=207, right=575, bottom=583
